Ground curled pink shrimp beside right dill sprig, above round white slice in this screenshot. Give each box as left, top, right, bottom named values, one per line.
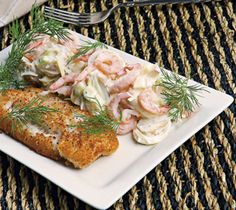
left=138, top=89, right=169, bottom=114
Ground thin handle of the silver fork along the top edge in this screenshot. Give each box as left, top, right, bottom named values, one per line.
left=119, top=0, right=209, bottom=7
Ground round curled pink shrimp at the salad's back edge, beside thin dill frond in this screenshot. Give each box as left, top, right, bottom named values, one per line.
left=93, top=50, right=125, bottom=75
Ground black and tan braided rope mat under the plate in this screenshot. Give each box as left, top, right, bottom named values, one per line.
left=0, top=0, right=236, bottom=210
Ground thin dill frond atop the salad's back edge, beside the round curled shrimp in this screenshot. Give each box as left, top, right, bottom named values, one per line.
left=68, top=41, right=107, bottom=64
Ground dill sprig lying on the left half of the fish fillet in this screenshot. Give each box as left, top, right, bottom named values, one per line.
left=0, top=97, right=58, bottom=132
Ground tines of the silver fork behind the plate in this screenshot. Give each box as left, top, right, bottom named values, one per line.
left=44, top=6, right=91, bottom=25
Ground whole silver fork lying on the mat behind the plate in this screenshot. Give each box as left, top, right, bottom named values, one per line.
left=44, top=0, right=209, bottom=25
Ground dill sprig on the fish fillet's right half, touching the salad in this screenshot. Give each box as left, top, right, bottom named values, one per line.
left=72, top=98, right=120, bottom=135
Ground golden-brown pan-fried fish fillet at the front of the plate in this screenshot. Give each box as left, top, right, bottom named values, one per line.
left=0, top=88, right=119, bottom=168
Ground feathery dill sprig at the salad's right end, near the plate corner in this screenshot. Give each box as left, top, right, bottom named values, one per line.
left=157, top=70, right=206, bottom=121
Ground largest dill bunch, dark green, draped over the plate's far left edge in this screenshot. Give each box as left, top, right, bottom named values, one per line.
left=0, top=6, right=69, bottom=90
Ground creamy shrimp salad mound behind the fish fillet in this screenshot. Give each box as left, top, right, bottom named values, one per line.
left=21, top=31, right=197, bottom=144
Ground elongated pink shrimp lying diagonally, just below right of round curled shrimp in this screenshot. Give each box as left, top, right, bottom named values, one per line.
left=109, top=63, right=141, bottom=93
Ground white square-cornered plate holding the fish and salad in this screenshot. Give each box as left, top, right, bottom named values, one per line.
left=0, top=35, right=233, bottom=209
